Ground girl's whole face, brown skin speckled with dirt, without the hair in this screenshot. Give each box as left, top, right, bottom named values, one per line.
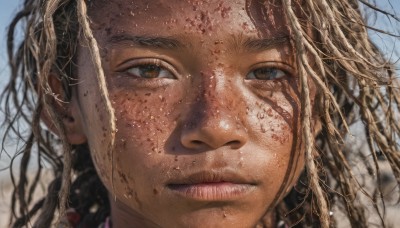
left=76, top=0, right=303, bottom=227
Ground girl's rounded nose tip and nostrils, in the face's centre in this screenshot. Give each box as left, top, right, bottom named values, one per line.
left=181, top=97, right=247, bottom=150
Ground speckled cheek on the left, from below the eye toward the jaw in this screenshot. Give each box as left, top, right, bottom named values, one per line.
left=111, top=92, right=177, bottom=193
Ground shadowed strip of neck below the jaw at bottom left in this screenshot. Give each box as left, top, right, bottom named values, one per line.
left=109, top=196, right=159, bottom=228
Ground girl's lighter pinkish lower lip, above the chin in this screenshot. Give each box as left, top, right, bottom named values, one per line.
left=168, top=182, right=255, bottom=201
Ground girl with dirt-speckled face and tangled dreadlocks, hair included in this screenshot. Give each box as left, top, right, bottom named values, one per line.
left=2, top=0, right=400, bottom=227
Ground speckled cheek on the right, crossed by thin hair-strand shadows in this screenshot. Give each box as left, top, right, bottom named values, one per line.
left=247, top=87, right=304, bottom=200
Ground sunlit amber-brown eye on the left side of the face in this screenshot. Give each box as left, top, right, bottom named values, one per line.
left=126, top=64, right=174, bottom=78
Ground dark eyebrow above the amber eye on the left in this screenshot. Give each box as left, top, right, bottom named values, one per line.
left=108, top=34, right=185, bottom=49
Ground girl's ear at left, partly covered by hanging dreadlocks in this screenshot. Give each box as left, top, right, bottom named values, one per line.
left=41, top=73, right=87, bottom=145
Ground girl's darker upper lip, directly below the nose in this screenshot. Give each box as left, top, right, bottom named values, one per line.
left=167, top=169, right=257, bottom=185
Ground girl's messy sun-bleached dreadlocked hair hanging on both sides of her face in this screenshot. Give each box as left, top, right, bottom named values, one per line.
left=1, top=0, right=400, bottom=228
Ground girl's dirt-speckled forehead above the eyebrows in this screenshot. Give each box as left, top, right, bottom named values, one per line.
left=89, top=0, right=288, bottom=38
